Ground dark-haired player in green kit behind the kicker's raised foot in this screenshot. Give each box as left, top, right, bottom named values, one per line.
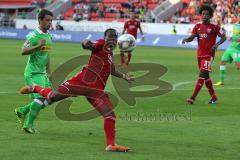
left=15, top=9, right=53, bottom=133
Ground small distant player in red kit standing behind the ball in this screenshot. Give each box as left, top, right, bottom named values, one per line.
left=120, top=12, right=144, bottom=67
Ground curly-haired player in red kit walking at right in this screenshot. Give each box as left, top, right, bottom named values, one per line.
left=182, top=5, right=226, bottom=104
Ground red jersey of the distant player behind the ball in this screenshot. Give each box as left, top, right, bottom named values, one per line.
left=124, top=19, right=141, bottom=39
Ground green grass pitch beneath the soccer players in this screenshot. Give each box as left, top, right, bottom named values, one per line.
left=0, top=40, right=240, bottom=160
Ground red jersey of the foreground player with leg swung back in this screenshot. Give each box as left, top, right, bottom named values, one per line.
left=72, top=39, right=113, bottom=86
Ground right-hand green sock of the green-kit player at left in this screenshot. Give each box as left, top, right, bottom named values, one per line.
left=23, top=101, right=42, bottom=128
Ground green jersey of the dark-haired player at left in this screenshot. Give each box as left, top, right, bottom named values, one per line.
left=23, top=28, right=52, bottom=76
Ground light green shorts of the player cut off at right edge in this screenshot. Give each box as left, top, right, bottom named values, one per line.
left=222, top=47, right=240, bottom=63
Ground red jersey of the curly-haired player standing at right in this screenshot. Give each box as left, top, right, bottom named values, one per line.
left=192, top=23, right=224, bottom=57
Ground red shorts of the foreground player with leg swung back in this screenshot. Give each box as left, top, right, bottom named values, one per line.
left=57, top=80, right=112, bottom=113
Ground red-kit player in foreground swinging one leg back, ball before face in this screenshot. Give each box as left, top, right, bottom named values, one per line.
left=20, top=28, right=134, bottom=152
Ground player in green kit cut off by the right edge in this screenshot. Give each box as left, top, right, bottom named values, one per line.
left=215, top=14, right=240, bottom=86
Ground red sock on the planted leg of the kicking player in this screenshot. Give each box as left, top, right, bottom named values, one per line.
left=104, top=116, right=115, bottom=146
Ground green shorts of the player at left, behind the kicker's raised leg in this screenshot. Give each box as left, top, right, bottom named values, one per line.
left=25, top=74, right=51, bottom=99
